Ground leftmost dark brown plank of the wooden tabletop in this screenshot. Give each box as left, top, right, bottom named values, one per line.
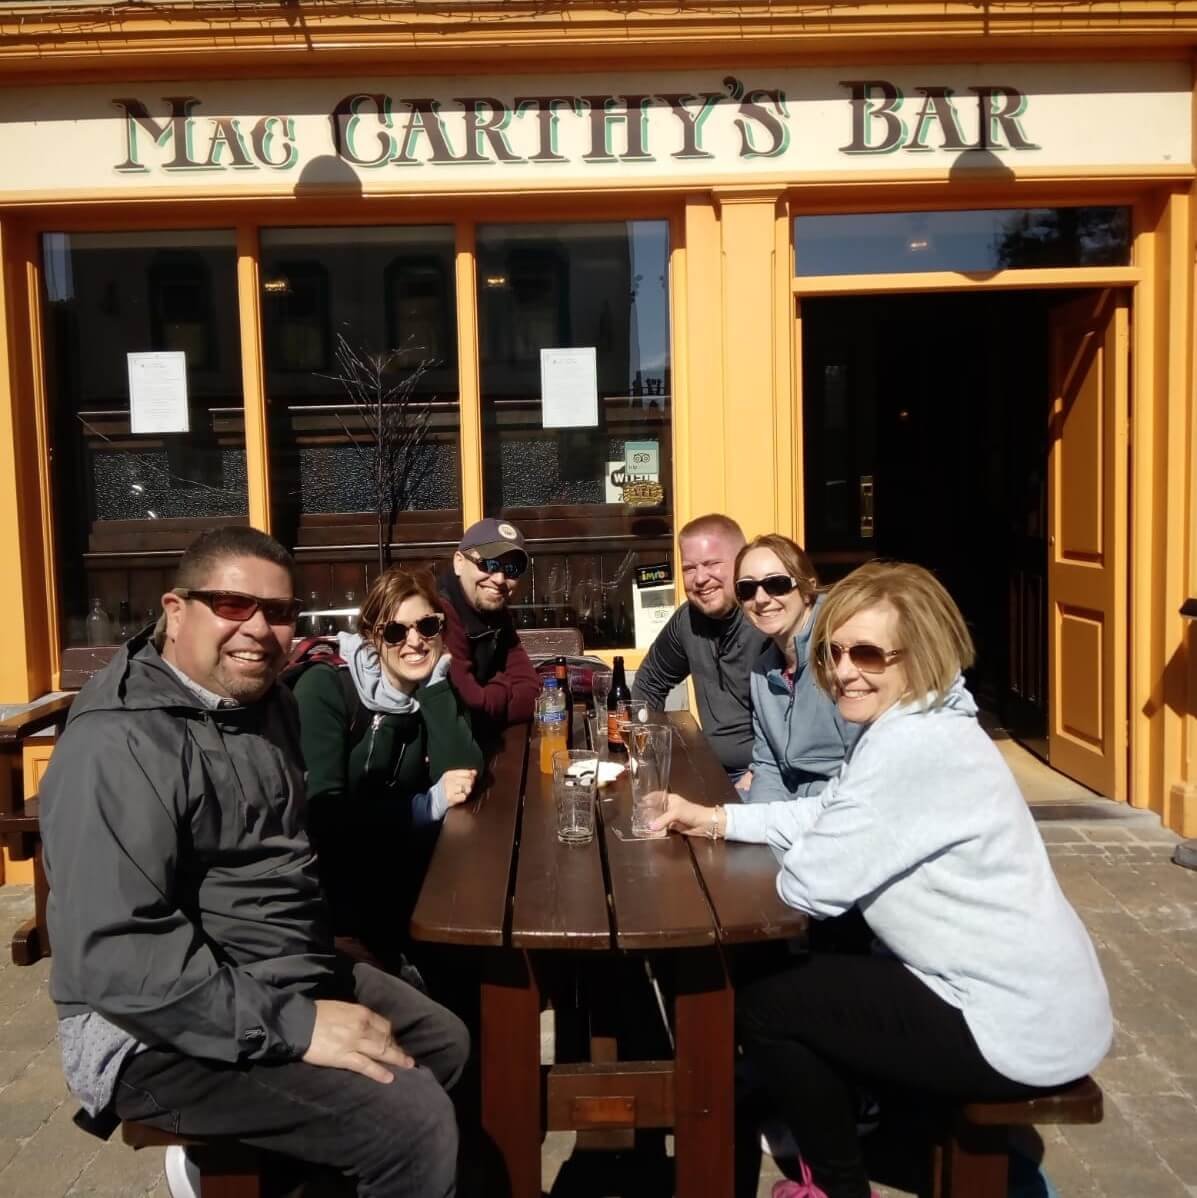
left=411, top=724, right=528, bottom=945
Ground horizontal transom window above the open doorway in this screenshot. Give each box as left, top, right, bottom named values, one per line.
left=794, top=207, right=1130, bottom=277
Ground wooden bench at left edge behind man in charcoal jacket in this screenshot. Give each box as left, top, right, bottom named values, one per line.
left=0, top=694, right=74, bottom=966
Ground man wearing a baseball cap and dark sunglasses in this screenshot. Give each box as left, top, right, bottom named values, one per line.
left=440, top=518, right=540, bottom=745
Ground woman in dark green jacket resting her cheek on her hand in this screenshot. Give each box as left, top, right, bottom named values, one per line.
left=295, top=567, right=483, bottom=961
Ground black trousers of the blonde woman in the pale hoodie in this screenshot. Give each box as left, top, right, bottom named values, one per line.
left=736, top=952, right=1054, bottom=1198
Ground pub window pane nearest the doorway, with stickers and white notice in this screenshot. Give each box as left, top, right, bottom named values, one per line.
left=477, top=220, right=673, bottom=648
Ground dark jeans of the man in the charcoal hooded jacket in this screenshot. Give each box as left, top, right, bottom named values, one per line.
left=116, top=964, right=470, bottom=1198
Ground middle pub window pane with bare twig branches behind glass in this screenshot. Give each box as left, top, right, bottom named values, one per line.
left=260, top=225, right=461, bottom=631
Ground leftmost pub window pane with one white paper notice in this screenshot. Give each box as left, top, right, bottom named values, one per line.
left=42, top=230, right=248, bottom=686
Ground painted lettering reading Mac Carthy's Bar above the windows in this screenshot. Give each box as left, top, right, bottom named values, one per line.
left=113, top=77, right=1039, bottom=173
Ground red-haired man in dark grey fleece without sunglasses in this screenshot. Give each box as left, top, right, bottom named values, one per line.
left=631, top=514, right=768, bottom=781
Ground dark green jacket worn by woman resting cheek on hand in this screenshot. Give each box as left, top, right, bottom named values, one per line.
left=295, top=665, right=484, bottom=939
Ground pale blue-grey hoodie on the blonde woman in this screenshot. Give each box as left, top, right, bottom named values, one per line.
left=726, top=677, right=1113, bottom=1085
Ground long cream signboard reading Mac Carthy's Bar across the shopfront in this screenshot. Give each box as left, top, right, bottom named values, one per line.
left=0, top=62, right=1190, bottom=196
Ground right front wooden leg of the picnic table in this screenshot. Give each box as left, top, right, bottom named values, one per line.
left=673, top=949, right=734, bottom=1198
